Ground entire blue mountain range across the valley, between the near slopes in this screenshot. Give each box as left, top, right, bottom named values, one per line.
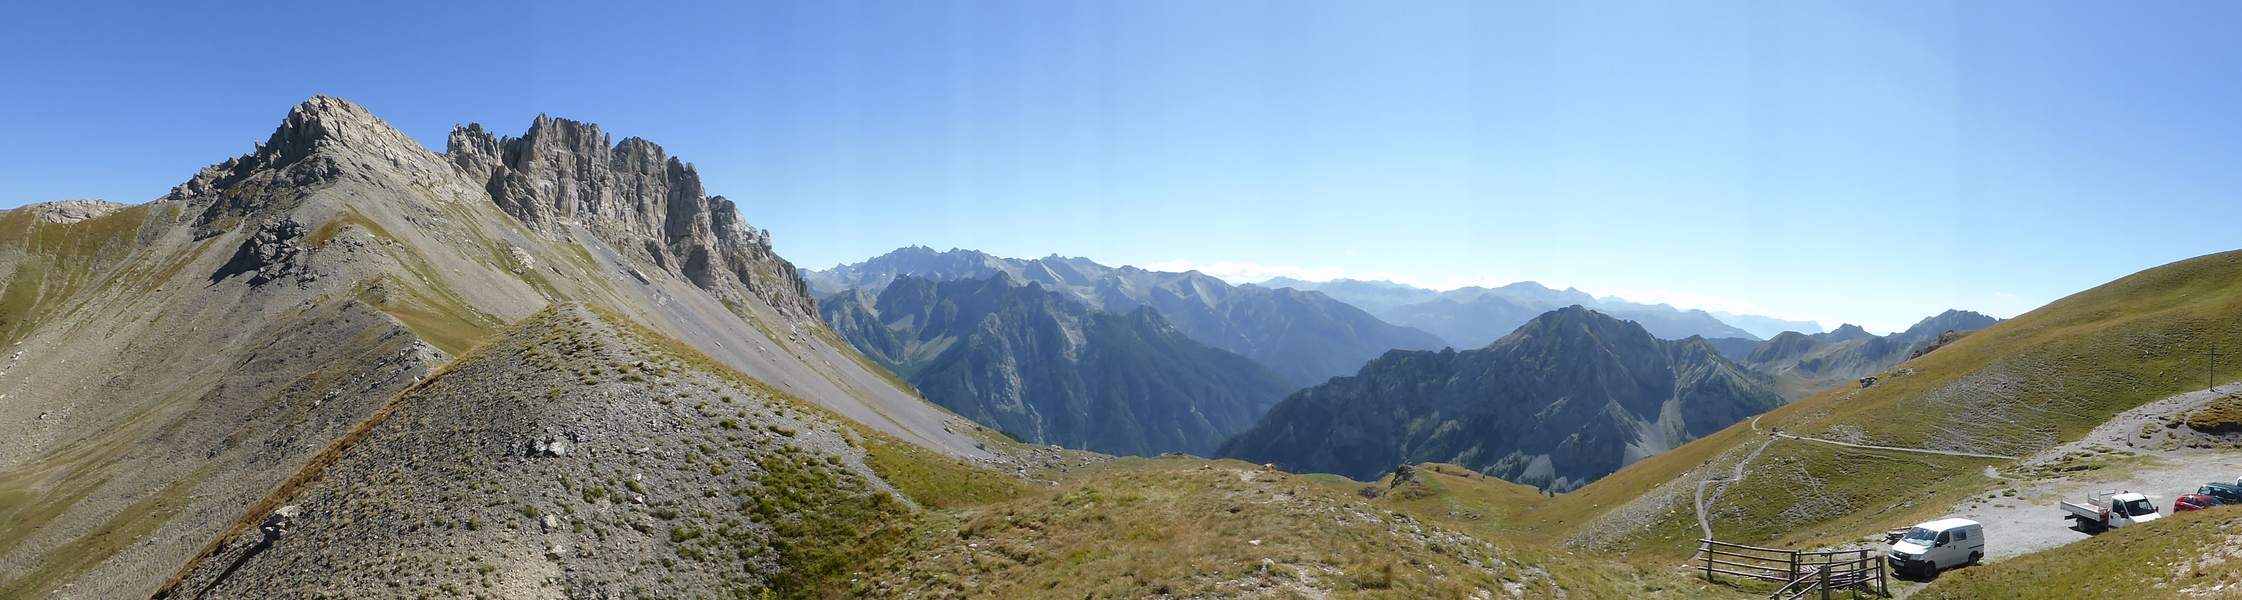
left=805, top=246, right=1995, bottom=490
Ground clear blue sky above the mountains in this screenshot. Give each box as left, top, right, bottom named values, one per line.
left=0, top=0, right=2242, bottom=329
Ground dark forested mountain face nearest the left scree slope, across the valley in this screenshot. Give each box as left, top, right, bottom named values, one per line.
left=821, top=271, right=1291, bottom=454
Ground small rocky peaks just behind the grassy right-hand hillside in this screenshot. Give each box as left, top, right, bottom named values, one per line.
left=1731, top=311, right=2000, bottom=399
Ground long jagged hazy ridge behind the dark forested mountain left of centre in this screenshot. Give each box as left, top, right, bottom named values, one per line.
left=805, top=246, right=1442, bottom=385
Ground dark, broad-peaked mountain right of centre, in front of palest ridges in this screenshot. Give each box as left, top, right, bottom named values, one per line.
left=1222, top=307, right=1782, bottom=490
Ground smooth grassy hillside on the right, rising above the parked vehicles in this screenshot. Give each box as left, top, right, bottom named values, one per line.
left=1551, top=253, right=2242, bottom=555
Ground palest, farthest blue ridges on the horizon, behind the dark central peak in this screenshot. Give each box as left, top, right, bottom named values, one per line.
left=1260, top=278, right=1766, bottom=349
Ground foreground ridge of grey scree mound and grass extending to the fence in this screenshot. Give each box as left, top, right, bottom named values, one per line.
left=170, top=307, right=1740, bottom=598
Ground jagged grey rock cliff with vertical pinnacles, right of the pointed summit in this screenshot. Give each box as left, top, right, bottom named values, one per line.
left=444, top=114, right=816, bottom=316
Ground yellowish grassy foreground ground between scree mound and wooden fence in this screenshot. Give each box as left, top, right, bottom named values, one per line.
left=865, top=459, right=1749, bottom=598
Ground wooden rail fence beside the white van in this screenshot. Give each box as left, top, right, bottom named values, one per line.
left=1697, top=540, right=1890, bottom=600
